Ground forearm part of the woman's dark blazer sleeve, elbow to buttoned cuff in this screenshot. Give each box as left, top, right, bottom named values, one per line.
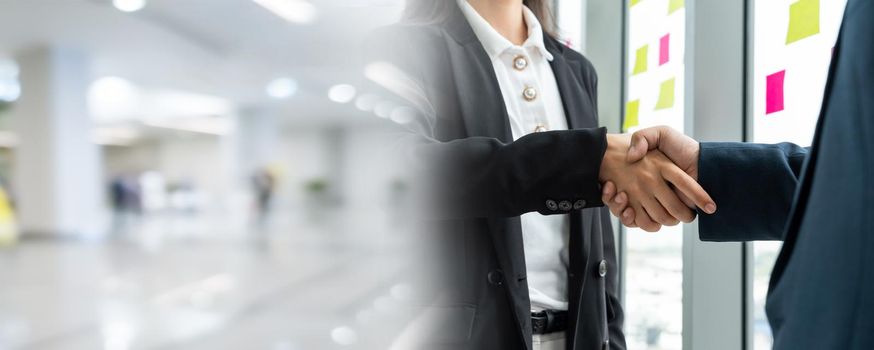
left=407, top=128, right=607, bottom=219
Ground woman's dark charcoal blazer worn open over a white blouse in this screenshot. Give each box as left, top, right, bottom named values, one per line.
left=370, top=2, right=625, bottom=350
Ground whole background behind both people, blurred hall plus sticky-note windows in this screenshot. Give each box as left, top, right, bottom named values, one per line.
left=0, top=0, right=844, bottom=350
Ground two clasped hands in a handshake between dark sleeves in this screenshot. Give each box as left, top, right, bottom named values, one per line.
left=599, top=126, right=716, bottom=232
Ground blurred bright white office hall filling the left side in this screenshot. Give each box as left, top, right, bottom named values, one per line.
left=0, top=0, right=418, bottom=350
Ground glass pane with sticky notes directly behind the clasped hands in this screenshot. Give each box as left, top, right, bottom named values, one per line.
left=623, top=0, right=686, bottom=350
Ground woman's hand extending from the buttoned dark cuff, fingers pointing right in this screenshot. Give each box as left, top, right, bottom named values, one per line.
left=600, top=134, right=713, bottom=232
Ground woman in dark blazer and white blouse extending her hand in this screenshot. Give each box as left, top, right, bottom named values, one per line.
left=368, top=0, right=709, bottom=350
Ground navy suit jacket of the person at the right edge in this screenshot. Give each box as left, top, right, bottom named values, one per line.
left=699, top=0, right=874, bottom=350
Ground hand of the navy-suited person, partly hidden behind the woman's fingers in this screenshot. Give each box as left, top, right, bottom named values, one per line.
left=602, top=126, right=716, bottom=229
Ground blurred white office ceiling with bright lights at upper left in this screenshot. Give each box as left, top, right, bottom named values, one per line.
left=0, top=0, right=403, bottom=127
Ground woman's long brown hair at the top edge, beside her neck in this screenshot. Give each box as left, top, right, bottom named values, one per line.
left=402, top=0, right=555, bottom=34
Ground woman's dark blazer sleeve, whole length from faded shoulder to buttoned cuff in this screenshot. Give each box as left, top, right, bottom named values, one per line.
left=368, top=26, right=607, bottom=220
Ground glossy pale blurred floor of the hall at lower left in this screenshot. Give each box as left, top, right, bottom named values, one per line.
left=0, top=211, right=406, bottom=350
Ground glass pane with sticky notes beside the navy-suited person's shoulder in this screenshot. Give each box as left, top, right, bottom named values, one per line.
left=752, top=0, right=846, bottom=349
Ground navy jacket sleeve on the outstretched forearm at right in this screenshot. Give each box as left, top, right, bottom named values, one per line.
left=698, top=143, right=809, bottom=241
